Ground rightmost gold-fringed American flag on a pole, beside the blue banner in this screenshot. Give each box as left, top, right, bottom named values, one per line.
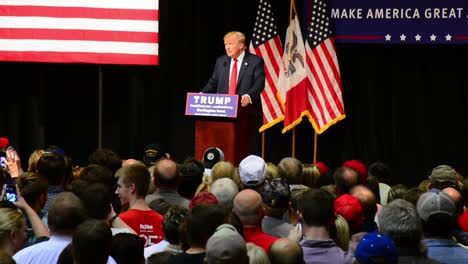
left=306, top=0, right=345, bottom=134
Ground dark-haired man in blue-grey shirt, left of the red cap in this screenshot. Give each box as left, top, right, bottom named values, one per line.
left=291, top=189, right=352, bottom=263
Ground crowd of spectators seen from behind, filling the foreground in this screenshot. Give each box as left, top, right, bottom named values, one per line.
left=0, top=145, right=468, bottom=264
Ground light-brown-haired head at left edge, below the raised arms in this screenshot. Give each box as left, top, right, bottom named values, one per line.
left=0, top=208, right=26, bottom=254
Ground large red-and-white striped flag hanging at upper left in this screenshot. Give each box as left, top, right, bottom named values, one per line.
left=0, top=0, right=159, bottom=65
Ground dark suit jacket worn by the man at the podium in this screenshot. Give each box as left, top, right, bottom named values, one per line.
left=201, top=52, right=265, bottom=104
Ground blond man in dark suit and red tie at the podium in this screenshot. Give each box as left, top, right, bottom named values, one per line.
left=201, top=31, right=265, bottom=107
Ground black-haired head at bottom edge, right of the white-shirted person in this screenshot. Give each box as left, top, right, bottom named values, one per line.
left=71, top=219, right=112, bottom=264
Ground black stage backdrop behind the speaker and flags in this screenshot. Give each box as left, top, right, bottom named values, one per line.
left=0, top=0, right=468, bottom=184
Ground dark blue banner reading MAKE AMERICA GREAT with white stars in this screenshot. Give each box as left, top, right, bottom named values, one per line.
left=330, top=0, right=468, bottom=44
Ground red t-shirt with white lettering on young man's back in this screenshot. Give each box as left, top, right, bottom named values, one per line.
left=119, top=209, right=164, bottom=247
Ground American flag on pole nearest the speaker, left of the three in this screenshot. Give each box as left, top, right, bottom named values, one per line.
left=249, top=0, right=284, bottom=132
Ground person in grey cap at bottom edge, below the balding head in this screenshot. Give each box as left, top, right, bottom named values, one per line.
left=206, top=224, right=249, bottom=264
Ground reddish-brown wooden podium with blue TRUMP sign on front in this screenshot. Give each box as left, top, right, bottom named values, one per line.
left=186, top=94, right=252, bottom=166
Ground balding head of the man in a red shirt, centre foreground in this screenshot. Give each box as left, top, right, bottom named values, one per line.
left=233, top=189, right=263, bottom=225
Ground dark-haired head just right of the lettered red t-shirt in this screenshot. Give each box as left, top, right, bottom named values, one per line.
left=162, top=205, right=189, bottom=245
